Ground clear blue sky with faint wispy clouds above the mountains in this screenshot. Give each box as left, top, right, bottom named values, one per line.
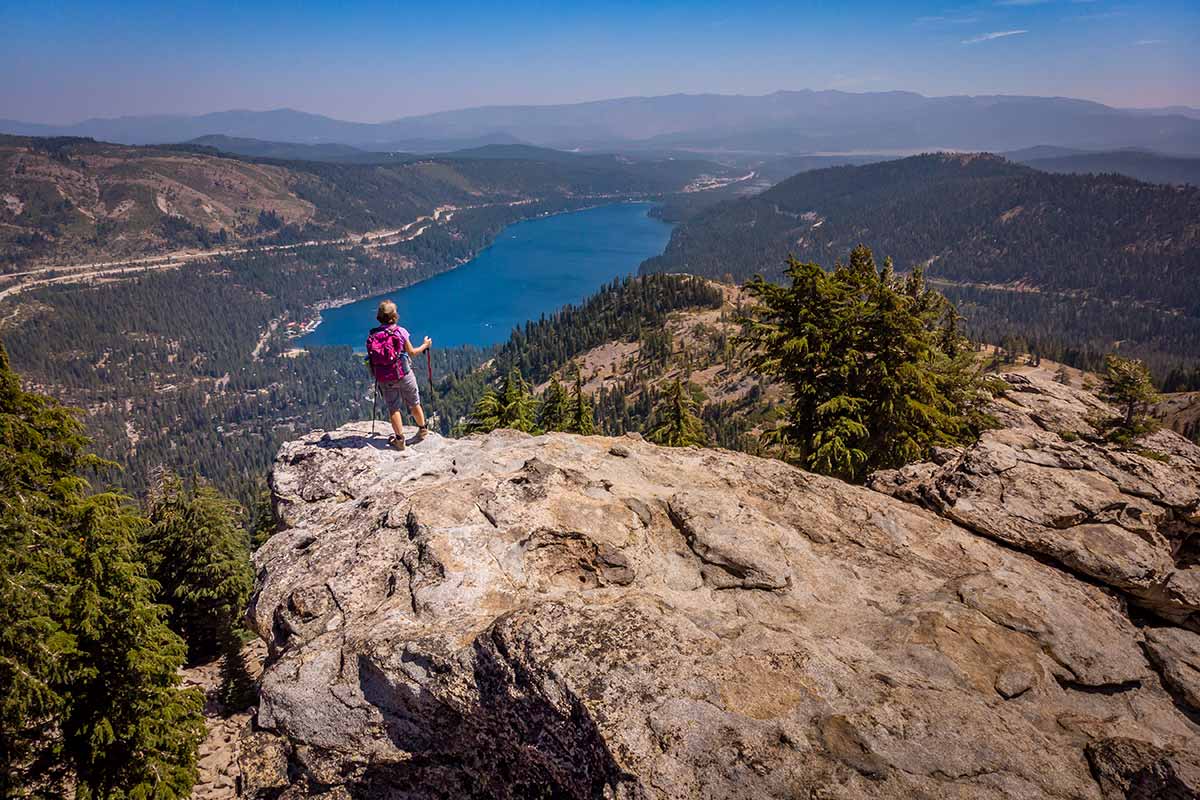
left=0, top=0, right=1200, bottom=124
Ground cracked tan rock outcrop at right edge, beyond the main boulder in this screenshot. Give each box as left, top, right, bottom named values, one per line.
left=871, top=374, right=1200, bottom=630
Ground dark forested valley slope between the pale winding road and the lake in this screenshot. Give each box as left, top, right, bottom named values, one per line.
left=0, top=193, right=590, bottom=503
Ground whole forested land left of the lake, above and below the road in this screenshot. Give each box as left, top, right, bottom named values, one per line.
left=0, top=137, right=726, bottom=504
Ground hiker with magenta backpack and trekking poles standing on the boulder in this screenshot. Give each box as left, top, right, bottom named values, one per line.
left=367, top=300, right=433, bottom=450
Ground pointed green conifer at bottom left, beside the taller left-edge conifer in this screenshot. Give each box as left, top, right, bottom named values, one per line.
left=62, top=494, right=204, bottom=800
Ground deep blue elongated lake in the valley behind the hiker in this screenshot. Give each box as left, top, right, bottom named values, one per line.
left=298, top=203, right=671, bottom=349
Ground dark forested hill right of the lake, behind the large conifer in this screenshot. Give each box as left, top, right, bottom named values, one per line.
left=642, top=154, right=1200, bottom=365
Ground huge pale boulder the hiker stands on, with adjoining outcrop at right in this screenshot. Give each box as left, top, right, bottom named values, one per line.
left=251, top=383, right=1200, bottom=799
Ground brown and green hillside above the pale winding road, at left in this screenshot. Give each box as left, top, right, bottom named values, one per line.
left=0, top=136, right=727, bottom=267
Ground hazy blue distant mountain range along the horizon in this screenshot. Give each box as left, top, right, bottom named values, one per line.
left=9, top=90, right=1200, bottom=155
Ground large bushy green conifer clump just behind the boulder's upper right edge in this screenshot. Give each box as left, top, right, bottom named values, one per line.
left=742, top=246, right=985, bottom=481
